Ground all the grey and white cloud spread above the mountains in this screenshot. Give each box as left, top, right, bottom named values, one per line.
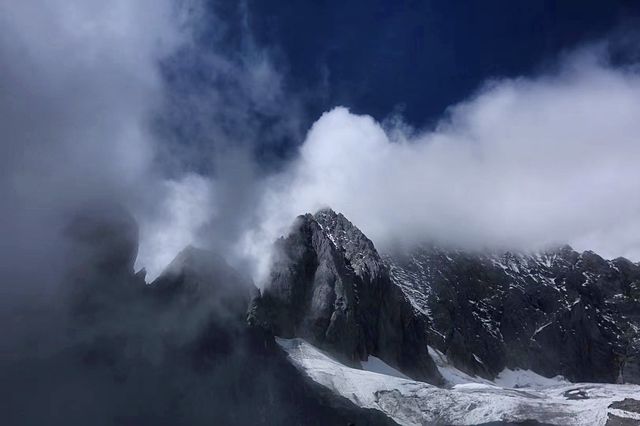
left=0, top=0, right=640, bottom=291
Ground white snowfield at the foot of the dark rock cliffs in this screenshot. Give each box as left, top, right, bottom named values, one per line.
left=277, top=339, right=640, bottom=426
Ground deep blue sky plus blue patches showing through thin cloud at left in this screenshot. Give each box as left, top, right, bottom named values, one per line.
left=159, top=0, right=640, bottom=170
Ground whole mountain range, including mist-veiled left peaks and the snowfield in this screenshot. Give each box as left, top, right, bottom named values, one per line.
left=23, top=209, right=640, bottom=425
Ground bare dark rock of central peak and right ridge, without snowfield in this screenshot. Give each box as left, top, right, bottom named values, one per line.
left=249, top=209, right=640, bottom=383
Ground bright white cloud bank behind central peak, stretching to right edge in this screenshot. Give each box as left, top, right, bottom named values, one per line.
left=242, top=46, right=640, bottom=280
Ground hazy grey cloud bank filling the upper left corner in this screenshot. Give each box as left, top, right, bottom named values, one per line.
left=0, top=0, right=181, bottom=303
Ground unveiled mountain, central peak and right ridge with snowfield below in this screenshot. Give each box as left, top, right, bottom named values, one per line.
left=249, top=209, right=640, bottom=425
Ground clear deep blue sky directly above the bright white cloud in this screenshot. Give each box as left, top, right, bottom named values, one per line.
left=248, top=0, right=638, bottom=126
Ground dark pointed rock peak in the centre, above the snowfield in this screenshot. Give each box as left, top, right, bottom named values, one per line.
left=249, top=210, right=441, bottom=383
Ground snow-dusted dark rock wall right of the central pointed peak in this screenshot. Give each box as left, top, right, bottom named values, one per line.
left=385, top=246, right=640, bottom=383
